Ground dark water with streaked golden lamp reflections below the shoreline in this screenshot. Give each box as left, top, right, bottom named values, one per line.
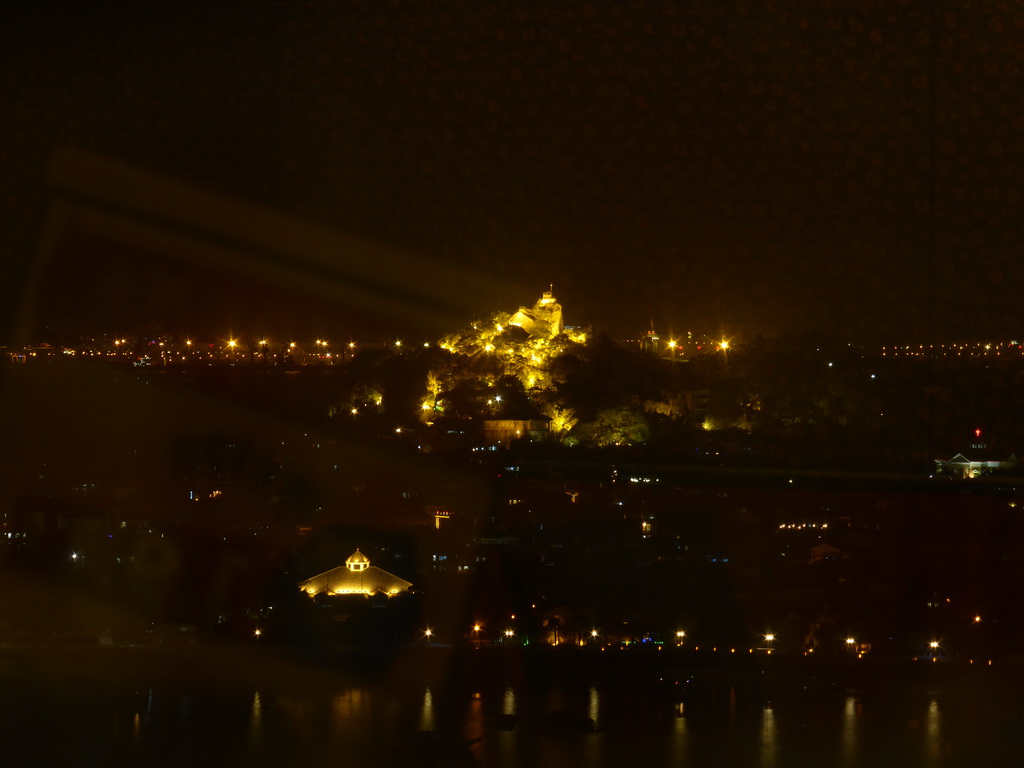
left=14, top=680, right=1024, bottom=768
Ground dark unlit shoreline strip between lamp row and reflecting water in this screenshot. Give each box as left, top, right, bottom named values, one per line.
left=0, top=644, right=1024, bottom=694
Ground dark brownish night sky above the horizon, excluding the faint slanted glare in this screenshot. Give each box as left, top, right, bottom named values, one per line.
left=0, top=0, right=1024, bottom=341
